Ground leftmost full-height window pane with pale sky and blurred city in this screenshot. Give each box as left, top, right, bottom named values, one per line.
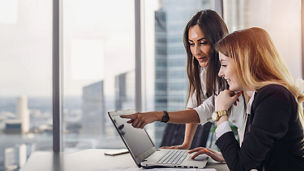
left=0, top=0, right=52, bottom=170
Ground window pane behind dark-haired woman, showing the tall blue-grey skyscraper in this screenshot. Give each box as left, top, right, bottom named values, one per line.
left=141, top=0, right=220, bottom=146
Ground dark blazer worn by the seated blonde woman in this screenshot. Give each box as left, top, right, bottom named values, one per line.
left=216, top=84, right=304, bottom=171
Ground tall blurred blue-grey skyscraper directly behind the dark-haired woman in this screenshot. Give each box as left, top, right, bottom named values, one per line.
left=155, top=0, right=211, bottom=144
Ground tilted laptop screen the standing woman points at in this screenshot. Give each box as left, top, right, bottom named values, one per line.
left=109, top=111, right=156, bottom=165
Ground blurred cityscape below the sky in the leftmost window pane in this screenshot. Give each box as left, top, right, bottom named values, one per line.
left=0, top=96, right=52, bottom=170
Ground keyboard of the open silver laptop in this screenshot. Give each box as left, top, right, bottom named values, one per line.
left=158, top=150, right=188, bottom=164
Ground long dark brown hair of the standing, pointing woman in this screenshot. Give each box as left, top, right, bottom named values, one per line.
left=184, top=10, right=228, bottom=105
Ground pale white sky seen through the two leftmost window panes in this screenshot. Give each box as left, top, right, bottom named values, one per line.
left=0, top=0, right=157, bottom=96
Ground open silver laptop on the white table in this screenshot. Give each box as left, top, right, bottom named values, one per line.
left=108, top=110, right=208, bottom=168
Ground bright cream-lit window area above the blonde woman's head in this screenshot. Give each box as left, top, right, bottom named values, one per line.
left=223, top=0, right=302, bottom=79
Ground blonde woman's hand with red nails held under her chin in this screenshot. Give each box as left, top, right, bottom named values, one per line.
left=215, top=90, right=242, bottom=111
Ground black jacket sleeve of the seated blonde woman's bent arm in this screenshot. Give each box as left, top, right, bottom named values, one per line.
left=216, top=86, right=292, bottom=171
